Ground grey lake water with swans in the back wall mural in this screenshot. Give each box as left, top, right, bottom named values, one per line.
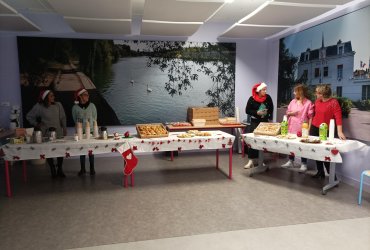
left=98, top=57, right=214, bottom=124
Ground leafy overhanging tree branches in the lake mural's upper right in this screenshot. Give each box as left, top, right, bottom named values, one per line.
left=144, top=41, right=235, bottom=116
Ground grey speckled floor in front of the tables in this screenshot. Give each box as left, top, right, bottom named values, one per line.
left=0, top=150, right=370, bottom=249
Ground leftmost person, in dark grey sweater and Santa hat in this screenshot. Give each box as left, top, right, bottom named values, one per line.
left=26, top=90, right=67, bottom=178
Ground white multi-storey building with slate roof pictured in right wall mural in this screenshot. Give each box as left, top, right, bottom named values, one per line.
left=298, top=37, right=370, bottom=101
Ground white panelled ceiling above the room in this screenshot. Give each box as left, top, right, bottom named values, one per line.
left=0, top=0, right=366, bottom=39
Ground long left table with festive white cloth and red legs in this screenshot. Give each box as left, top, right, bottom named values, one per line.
left=1, top=131, right=235, bottom=197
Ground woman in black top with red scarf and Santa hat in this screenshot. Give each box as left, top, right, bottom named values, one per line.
left=244, top=82, right=274, bottom=168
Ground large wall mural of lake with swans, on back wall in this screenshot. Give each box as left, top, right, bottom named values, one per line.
left=18, top=37, right=235, bottom=126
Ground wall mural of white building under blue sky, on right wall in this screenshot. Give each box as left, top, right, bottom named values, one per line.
left=277, top=7, right=370, bottom=141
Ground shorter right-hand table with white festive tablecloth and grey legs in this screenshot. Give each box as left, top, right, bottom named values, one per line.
left=242, top=133, right=366, bottom=194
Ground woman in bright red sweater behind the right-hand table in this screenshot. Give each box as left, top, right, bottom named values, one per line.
left=310, top=84, right=346, bottom=179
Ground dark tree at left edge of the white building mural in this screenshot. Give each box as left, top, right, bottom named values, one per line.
left=278, top=39, right=298, bottom=106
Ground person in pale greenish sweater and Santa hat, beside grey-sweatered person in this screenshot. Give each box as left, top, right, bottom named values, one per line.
left=72, top=88, right=97, bottom=176
